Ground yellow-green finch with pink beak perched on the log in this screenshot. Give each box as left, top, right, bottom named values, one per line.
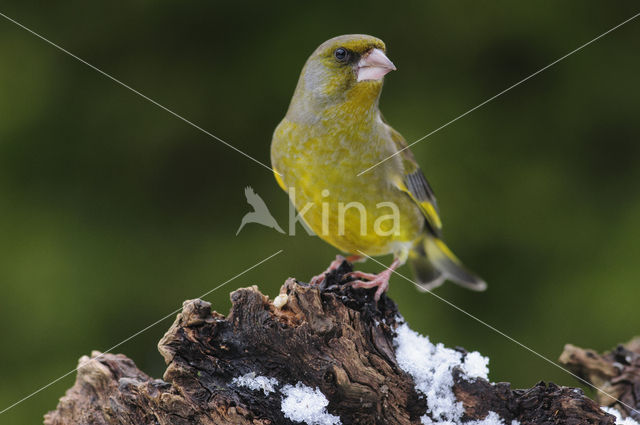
left=271, top=34, right=487, bottom=301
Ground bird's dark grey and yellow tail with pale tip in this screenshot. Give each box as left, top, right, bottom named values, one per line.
left=409, top=234, right=487, bottom=291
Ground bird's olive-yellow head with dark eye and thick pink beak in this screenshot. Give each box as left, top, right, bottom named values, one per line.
left=288, top=34, right=396, bottom=117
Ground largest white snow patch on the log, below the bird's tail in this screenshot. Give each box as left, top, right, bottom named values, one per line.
left=394, top=323, right=518, bottom=425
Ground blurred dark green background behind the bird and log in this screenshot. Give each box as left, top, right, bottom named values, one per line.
left=0, top=0, right=640, bottom=424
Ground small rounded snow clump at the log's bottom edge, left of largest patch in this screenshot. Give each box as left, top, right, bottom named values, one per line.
left=281, top=382, right=342, bottom=425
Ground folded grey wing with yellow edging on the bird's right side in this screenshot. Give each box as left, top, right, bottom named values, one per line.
left=387, top=124, right=442, bottom=236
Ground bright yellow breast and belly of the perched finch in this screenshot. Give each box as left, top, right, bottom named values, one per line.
left=272, top=117, right=424, bottom=254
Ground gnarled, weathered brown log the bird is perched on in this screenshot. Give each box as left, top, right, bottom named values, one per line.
left=45, top=263, right=638, bottom=425
